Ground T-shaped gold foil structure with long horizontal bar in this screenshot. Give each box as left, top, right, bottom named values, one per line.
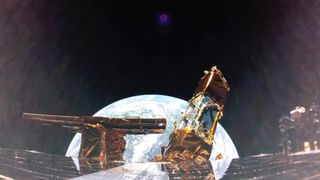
left=23, top=113, right=166, bottom=167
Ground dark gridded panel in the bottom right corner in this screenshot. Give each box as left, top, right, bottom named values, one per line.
left=223, top=153, right=320, bottom=179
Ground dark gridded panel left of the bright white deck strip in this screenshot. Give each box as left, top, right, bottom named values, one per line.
left=0, top=148, right=121, bottom=179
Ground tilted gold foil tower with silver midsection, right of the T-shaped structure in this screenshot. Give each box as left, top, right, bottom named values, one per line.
left=161, top=67, right=230, bottom=163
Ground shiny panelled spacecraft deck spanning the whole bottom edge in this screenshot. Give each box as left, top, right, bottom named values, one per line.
left=0, top=148, right=320, bottom=179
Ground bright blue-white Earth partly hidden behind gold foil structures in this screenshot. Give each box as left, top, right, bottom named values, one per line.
left=66, top=95, right=239, bottom=162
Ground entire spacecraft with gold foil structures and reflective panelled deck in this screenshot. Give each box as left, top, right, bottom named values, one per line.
left=0, top=67, right=320, bottom=180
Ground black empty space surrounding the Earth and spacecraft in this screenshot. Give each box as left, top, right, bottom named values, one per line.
left=0, top=0, right=320, bottom=156
